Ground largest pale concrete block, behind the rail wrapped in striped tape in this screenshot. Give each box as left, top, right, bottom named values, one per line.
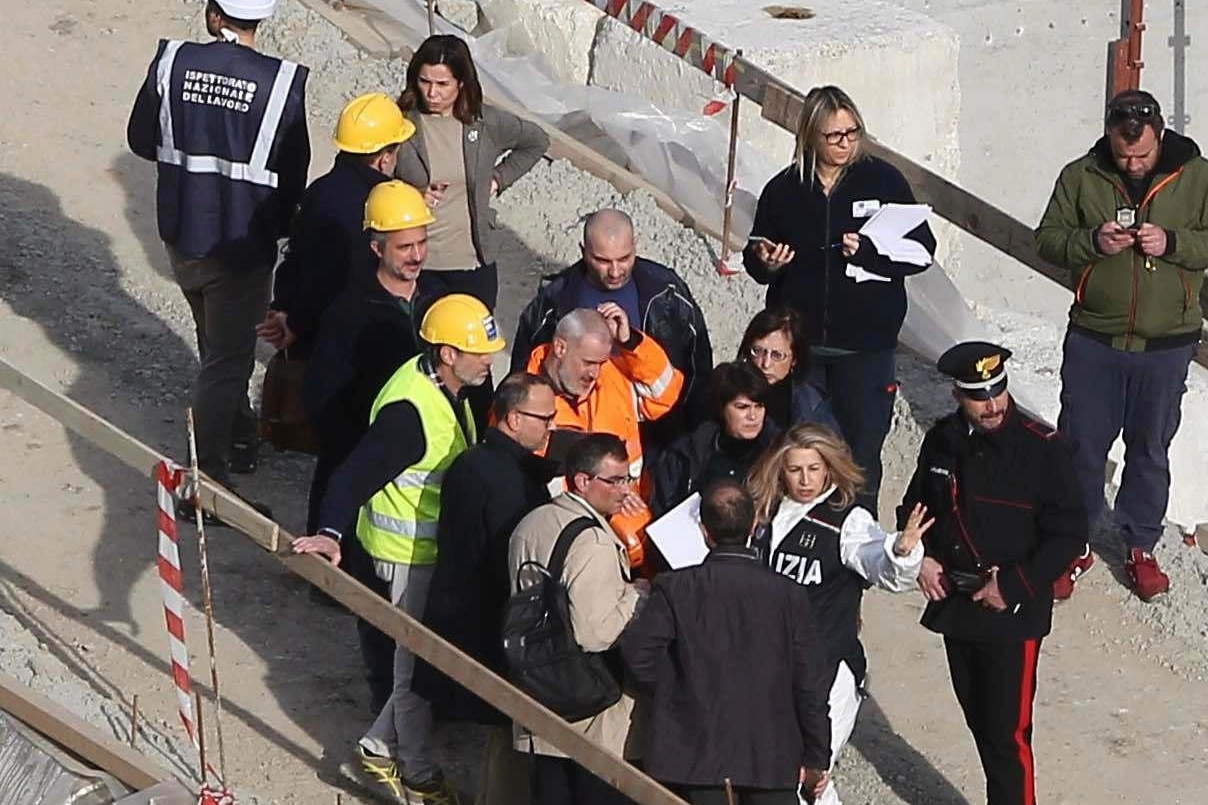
left=576, top=0, right=960, bottom=266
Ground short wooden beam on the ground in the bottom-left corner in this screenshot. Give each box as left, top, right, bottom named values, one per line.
left=0, top=673, right=173, bottom=790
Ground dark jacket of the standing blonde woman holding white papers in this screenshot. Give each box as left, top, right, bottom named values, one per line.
left=743, top=157, right=935, bottom=352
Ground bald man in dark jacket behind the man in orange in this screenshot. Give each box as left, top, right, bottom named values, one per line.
left=512, top=209, right=713, bottom=457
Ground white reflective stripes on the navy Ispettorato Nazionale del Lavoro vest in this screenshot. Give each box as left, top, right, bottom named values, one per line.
left=156, top=40, right=297, bottom=187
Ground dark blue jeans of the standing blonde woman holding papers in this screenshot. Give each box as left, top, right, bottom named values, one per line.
left=809, top=349, right=898, bottom=507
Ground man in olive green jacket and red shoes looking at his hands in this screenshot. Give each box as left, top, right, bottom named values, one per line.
left=1035, top=91, right=1208, bottom=601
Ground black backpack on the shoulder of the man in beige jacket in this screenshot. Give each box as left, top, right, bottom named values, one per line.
left=503, top=517, right=621, bottom=722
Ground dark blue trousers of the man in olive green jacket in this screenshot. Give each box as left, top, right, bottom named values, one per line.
left=1057, top=331, right=1195, bottom=551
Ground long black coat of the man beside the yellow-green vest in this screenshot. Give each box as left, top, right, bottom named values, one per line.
left=412, top=428, right=557, bottom=724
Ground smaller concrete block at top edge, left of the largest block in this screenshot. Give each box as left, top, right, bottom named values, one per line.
left=480, top=0, right=605, bottom=85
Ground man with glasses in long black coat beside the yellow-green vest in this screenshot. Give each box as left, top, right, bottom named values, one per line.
left=412, top=372, right=558, bottom=801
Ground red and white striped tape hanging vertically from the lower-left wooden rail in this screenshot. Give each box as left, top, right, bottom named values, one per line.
left=155, top=462, right=197, bottom=746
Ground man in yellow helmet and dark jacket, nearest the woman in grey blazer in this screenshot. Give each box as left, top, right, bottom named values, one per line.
left=256, top=92, right=416, bottom=360
